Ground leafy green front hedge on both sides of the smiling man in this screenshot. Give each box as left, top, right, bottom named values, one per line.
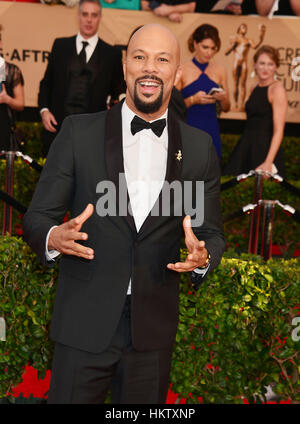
left=0, top=237, right=300, bottom=403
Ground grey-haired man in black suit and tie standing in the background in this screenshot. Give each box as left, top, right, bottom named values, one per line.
left=38, top=0, right=125, bottom=156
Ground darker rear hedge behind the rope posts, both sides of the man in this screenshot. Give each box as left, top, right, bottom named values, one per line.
left=0, top=158, right=300, bottom=258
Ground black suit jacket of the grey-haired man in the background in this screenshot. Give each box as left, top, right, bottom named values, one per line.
left=38, top=36, right=125, bottom=126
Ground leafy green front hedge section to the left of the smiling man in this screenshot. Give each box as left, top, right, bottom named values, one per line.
left=0, top=237, right=57, bottom=398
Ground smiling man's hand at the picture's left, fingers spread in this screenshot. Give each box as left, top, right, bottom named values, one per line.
left=48, top=203, right=94, bottom=259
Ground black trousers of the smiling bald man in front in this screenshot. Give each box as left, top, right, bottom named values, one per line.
left=48, top=296, right=173, bottom=404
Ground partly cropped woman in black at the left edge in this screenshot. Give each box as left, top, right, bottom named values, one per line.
left=0, top=25, right=24, bottom=151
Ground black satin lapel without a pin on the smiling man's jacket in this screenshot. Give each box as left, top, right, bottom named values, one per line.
left=105, top=102, right=136, bottom=233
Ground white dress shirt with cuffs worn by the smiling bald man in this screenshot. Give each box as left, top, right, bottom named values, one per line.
left=46, top=101, right=209, bottom=294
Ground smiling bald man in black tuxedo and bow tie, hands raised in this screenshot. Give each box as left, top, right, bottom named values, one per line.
left=23, top=24, right=224, bottom=403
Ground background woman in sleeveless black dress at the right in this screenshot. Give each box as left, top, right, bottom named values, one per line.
left=223, top=46, right=288, bottom=175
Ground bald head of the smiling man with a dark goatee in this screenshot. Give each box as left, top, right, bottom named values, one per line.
left=124, top=24, right=180, bottom=120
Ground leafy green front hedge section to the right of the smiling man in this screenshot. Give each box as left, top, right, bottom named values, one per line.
left=171, top=252, right=300, bottom=403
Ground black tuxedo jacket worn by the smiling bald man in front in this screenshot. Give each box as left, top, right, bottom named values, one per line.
left=23, top=104, right=224, bottom=352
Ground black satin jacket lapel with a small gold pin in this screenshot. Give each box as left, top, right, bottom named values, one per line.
left=138, top=109, right=182, bottom=239
